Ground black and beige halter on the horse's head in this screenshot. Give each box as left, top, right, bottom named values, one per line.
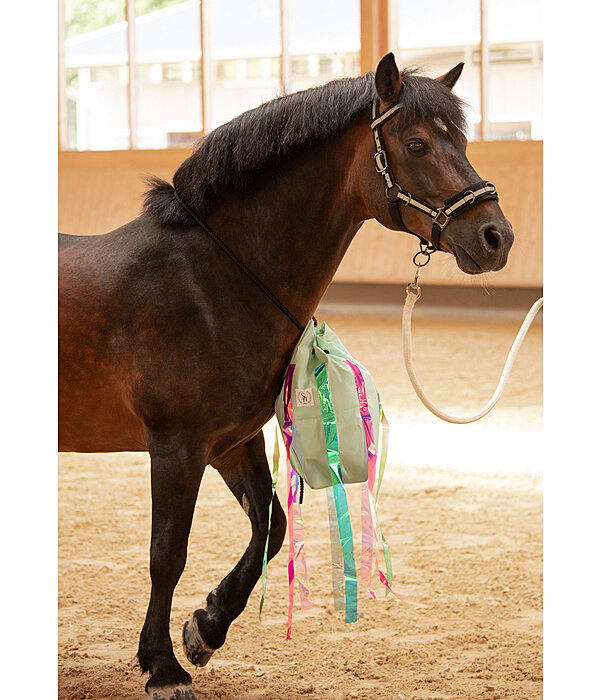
left=371, top=97, right=498, bottom=252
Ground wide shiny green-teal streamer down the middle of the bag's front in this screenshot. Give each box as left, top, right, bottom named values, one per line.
left=315, top=364, right=358, bottom=622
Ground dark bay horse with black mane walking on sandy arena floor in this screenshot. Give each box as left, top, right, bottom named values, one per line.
left=59, top=54, right=513, bottom=700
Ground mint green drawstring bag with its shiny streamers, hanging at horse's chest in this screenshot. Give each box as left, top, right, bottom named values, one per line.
left=260, top=321, right=397, bottom=639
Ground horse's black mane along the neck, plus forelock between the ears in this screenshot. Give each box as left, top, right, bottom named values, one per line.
left=144, top=69, right=466, bottom=226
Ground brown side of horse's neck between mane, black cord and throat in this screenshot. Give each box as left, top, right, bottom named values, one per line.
left=208, top=128, right=364, bottom=319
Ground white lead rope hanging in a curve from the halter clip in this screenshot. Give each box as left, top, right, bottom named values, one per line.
left=402, top=278, right=544, bottom=423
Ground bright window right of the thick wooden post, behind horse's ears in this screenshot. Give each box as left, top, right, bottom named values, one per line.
left=391, top=0, right=543, bottom=140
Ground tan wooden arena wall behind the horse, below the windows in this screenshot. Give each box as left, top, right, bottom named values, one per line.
left=58, top=141, right=543, bottom=287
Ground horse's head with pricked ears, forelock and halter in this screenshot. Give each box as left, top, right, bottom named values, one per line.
left=361, top=54, right=514, bottom=274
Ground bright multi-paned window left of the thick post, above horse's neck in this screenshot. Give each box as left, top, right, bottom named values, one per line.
left=61, top=0, right=360, bottom=150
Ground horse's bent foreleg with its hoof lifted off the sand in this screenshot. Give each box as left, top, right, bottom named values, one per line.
left=183, top=431, right=286, bottom=666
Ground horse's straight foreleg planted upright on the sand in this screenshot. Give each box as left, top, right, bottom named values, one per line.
left=138, top=434, right=206, bottom=700
